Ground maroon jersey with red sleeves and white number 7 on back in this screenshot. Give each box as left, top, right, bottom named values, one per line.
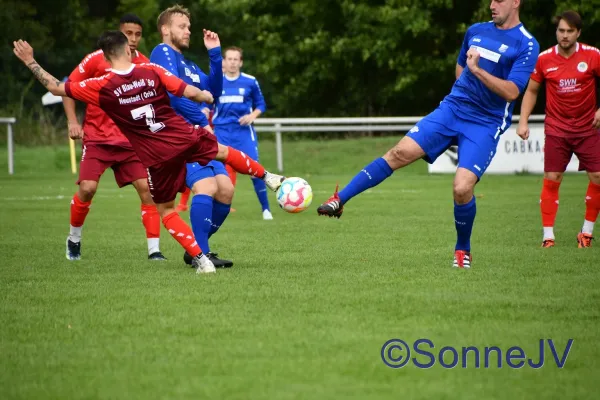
left=65, top=63, right=198, bottom=167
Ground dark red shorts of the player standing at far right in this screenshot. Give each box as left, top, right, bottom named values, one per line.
left=544, top=133, right=600, bottom=172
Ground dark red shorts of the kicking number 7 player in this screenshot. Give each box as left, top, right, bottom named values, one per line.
left=148, top=128, right=219, bottom=204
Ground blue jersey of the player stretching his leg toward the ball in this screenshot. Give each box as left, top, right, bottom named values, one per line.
left=444, top=22, right=540, bottom=133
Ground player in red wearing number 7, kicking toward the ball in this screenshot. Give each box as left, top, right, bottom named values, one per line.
left=14, top=31, right=284, bottom=273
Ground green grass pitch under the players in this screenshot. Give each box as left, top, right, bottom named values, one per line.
left=0, top=138, right=600, bottom=399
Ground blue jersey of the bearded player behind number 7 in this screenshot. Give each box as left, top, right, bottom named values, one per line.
left=150, top=43, right=223, bottom=127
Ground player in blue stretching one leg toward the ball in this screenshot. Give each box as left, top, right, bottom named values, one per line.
left=318, top=0, right=539, bottom=268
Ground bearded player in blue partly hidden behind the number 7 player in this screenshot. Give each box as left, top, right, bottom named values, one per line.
left=150, top=5, right=234, bottom=268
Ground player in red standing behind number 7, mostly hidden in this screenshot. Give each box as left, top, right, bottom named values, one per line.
left=63, top=14, right=166, bottom=260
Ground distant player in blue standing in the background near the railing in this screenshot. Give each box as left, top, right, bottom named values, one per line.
left=212, top=47, right=273, bottom=220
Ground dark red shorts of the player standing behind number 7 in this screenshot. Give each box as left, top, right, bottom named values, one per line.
left=77, top=143, right=148, bottom=187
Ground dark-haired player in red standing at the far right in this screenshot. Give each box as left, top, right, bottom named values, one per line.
left=517, top=11, right=600, bottom=248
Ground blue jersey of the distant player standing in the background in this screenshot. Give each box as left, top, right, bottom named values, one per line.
left=213, top=73, right=267, bottom=127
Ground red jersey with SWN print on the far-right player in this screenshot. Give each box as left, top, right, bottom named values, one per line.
left=531, top=43, right=600, bottom=137
